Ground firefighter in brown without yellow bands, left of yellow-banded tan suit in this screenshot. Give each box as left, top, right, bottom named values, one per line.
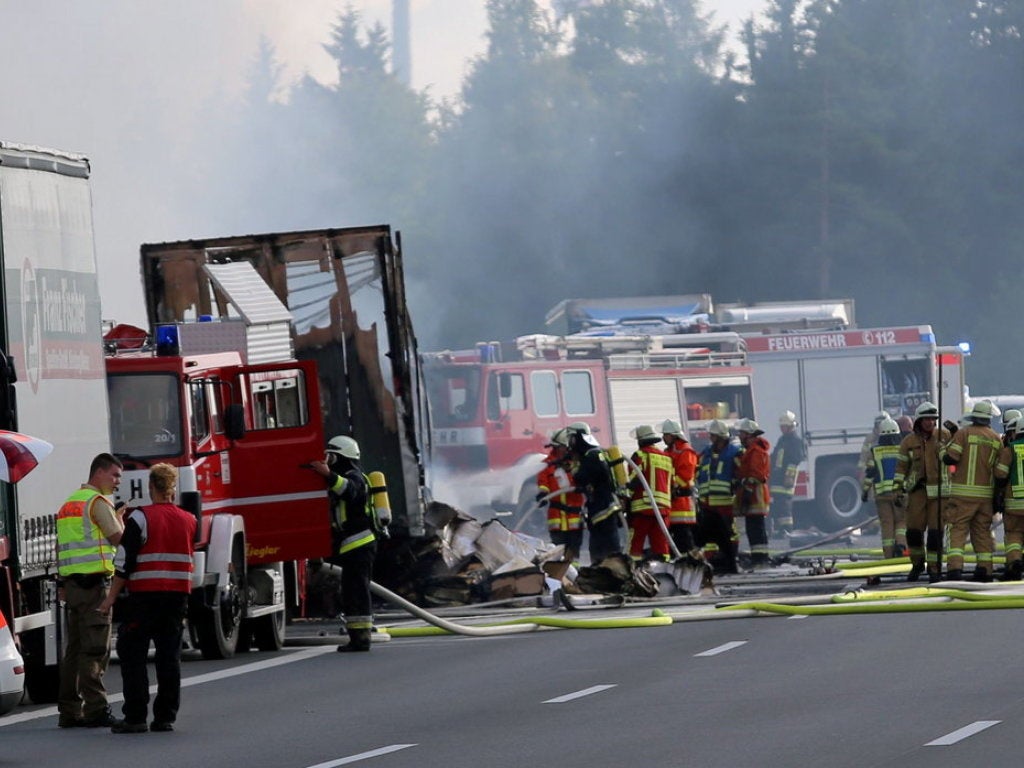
left=893, top=400, right=949, bottom=584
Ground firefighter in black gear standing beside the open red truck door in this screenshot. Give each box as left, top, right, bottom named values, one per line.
left=310, top=435, right=377, bottom=653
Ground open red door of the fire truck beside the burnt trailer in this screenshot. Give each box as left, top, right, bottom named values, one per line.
left=230, top=361, right=329, bottom=563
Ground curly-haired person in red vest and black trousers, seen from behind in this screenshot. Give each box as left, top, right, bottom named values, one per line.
left=98, top=463, right=198, bottom=733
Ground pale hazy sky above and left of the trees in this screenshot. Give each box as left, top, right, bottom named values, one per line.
left=0, top=0, right=765, bottom=325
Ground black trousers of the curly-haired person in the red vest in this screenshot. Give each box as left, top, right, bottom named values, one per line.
left=118, top=592, right=188, bottom=723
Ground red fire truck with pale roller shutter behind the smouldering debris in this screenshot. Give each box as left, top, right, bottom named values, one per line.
left=423, top=325, right=755, bottom=524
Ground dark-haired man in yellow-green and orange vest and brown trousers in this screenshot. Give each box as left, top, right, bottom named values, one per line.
left=57, top=454, right=124, bottom=728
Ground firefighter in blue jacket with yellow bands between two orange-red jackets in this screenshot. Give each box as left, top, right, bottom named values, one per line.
left=697, top=419, right=739, bottom=573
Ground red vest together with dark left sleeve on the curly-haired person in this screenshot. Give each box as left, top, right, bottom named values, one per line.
left=114, top=504, right=197, bottom=594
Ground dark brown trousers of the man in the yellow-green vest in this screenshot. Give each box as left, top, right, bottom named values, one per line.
left=57, top=575, right=111, bottom=720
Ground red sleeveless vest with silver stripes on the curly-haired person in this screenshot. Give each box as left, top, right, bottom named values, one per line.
left=128, top=504, right=196, bottom=594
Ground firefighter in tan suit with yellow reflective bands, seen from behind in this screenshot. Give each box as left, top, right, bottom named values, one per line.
left=939, top=400, right=1009, bottom=582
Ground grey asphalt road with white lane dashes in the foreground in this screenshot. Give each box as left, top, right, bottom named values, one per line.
left=0, top=609, right=1024, bottom=768
